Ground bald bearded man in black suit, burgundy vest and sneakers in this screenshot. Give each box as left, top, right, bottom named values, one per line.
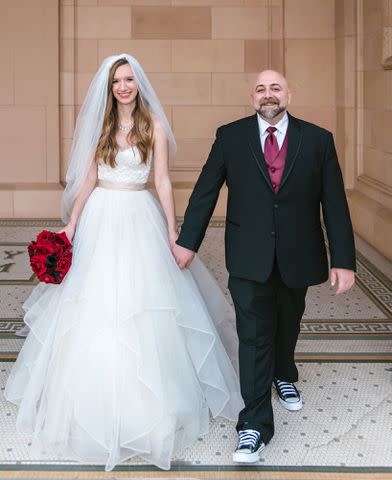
left=173, top=70, right=355, bottom=463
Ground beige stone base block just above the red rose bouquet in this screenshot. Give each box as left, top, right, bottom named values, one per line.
left=14, top=188, right=62, bottom=218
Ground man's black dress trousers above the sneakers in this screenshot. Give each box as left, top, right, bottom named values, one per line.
left=229, top=261, right=307, bottom=443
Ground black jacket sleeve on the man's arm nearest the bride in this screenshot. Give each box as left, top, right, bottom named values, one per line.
left=177, top=128, right=226, bottom=252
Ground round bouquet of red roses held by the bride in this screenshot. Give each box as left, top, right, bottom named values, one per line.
left=27, top=230, right=72, bottom=283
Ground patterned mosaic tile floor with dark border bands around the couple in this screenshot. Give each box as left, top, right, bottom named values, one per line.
left=0, top=221, right=392, bottom=478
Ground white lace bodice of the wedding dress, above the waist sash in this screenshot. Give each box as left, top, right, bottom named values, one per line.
left=98, top=147, right=151, bottom=183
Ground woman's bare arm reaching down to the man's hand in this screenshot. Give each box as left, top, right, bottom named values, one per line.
left=154, top=122, right=178, bottom=247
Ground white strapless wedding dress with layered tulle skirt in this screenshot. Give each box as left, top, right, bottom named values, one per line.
left=5, top=148, right=243, bottom=470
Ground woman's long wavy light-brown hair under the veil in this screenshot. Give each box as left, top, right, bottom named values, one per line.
left=95, top=58, right=154, bottom=167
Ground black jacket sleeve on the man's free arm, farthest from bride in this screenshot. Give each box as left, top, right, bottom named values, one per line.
left=321, top=133, right=356, bottom=271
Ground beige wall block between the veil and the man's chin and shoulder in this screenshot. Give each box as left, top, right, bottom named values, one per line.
left=173, top=106, right=245, bottom=139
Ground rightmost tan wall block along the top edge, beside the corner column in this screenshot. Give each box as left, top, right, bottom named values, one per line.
left=284, top=0, right=335, bottom=39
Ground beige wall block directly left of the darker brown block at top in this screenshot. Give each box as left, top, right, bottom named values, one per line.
left=76, top=6, right=132, bottom=38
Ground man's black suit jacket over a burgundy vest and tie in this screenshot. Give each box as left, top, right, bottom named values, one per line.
left=177, top=115, right=355, bottom=288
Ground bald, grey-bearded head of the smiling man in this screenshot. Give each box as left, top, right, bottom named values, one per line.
left=251, top=70, right=291, bottom=124
